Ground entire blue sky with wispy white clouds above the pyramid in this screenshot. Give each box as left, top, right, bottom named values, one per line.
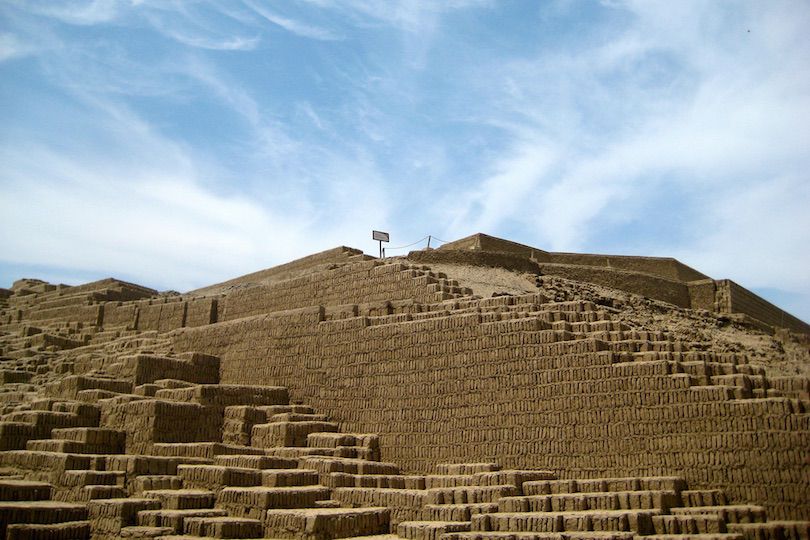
left=0, top=0, right=810, bottom=320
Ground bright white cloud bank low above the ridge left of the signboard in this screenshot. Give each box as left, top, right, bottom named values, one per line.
left=0, top=137, right=384, bottom=290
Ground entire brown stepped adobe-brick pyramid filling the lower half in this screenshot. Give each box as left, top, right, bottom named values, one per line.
left=0, top=234, right=810, bottom=540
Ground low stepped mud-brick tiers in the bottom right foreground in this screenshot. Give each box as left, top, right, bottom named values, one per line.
left=396, top=464, right=810, bottom=540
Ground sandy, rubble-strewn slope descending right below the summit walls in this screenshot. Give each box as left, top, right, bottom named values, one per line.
left=410, top=264, right=810, bottom=377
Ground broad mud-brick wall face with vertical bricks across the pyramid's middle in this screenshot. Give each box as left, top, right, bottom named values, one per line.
left=175, top=308, right=810, bottom=519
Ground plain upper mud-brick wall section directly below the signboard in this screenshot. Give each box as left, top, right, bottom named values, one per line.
left=218, top=261, right=458, bottom=320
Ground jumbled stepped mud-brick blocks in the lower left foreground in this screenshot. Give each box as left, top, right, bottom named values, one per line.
left=0, top=348, right=400, bottom=539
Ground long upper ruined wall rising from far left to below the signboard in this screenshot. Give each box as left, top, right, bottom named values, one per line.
left=3, top=258, right=472, bottom=333
